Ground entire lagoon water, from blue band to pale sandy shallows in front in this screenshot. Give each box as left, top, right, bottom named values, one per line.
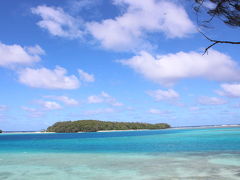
left=0, top=128, right=240, bottom=180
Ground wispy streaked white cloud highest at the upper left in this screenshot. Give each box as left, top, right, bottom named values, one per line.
left=31, top=5, right=83, bottom=39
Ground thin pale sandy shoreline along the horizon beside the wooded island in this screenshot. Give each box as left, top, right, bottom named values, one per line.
left=1, top=124, right=240, bottom=134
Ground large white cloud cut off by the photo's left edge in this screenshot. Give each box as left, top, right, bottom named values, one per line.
left=0, top=42, right=44, bottom=67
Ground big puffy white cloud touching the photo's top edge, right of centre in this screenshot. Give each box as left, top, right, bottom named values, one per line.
left=86, top=0, right=195, bottom=50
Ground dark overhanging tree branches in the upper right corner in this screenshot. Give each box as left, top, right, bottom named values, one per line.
left=194, top=0, right=240, bottom=54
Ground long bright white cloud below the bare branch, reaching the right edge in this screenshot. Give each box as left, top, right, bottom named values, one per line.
left=119, top=49, right=240, bottom=86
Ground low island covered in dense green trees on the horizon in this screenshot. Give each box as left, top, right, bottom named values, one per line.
left=47, top=120, right=170, bottom=133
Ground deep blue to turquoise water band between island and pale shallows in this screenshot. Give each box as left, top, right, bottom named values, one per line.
left=0, top=127, right=240, bottom=153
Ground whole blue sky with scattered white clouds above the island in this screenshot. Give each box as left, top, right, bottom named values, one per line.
left=0, top=0, right=240, bottom=131
